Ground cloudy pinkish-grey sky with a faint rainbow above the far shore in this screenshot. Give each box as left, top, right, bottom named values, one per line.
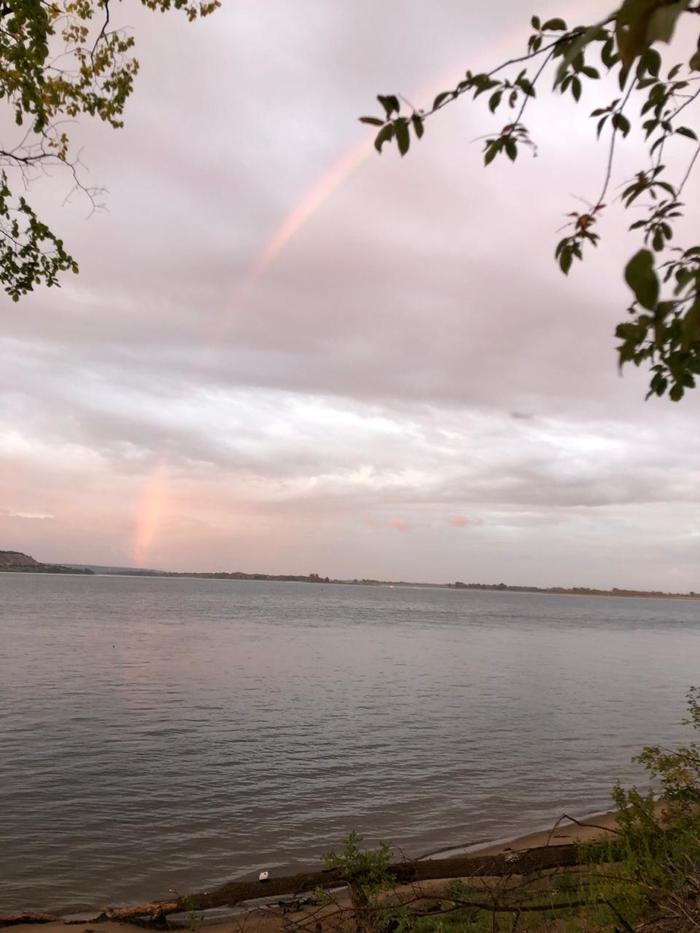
left=0, top=0, right=700, bottom=591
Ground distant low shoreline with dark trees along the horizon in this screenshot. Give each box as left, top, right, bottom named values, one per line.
left=0, top=551, right=700, bottom=599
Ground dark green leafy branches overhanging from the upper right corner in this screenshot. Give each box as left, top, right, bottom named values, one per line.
left=360, top=0, right=700, bottom=401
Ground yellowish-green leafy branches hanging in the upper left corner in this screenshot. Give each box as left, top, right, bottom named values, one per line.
left=0, top=0, right=220, bottom=301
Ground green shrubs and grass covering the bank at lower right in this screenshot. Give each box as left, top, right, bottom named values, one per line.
left=296, top=687, right=700, bottom=933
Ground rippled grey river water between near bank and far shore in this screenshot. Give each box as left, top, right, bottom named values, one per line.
left=0, top=574, right=700, bottom=911
